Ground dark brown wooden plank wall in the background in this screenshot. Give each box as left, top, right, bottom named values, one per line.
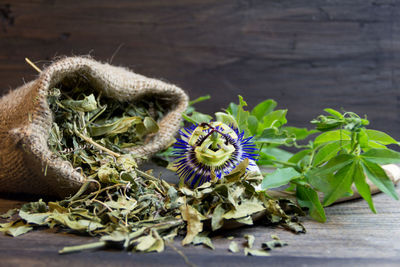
left=0, top=0, right=400, bottom=138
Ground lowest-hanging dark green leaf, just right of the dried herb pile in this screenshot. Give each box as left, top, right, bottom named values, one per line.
left=296, top=185, right=326, bottom=222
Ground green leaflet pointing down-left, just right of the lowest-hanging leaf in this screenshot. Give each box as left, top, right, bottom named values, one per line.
left=323, top=160, right=358, bottom=206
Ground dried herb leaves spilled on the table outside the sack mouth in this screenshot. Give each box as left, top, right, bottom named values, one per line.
left=0, top=161, right=304, bottom=254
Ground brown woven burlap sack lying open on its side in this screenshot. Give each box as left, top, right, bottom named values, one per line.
left=0, top=57, right=188, bottom=197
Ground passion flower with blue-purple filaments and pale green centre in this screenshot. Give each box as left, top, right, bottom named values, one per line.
left=174, top=122, right=258, bottom=187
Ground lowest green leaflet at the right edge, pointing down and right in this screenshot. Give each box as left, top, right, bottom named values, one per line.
left=361, top=158, right=399, bottom=200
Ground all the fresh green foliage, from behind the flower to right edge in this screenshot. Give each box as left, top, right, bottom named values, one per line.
left=184, top=96, right=400, bottom=222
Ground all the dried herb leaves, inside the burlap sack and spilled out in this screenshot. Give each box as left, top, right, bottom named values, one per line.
left=0, top=82, right=304, bottom=254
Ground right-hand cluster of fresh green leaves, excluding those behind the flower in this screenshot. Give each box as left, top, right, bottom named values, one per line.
left=262, top=109, right=400, bottom=222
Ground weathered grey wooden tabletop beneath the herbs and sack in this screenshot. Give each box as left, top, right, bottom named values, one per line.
left=0, top=165, right=400, bottom=267
